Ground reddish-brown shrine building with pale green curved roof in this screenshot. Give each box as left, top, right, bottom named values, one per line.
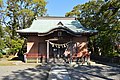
left=17, top=17, right=97, bottom=63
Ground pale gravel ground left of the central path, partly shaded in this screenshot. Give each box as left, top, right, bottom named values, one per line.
left=0, top=64, right=50, bottom=80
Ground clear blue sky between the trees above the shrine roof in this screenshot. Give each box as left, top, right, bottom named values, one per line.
left=46, top=0, right=89, bottom=16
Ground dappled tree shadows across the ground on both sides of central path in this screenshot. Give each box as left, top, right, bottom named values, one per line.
left=2, top=63, right=120, bottom=80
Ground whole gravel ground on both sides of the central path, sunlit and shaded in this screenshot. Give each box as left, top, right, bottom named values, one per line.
left=0, top=62, right=120, bottom=80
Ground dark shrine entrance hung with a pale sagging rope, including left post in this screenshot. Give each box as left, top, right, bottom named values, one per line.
left=46, top=39, right=72, bottom=60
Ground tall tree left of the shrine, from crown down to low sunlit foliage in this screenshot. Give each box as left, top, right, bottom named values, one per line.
left=2, top=0, right=46, bottom=54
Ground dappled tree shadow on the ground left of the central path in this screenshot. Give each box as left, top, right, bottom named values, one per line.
left=2, top=64, right=53, bottom=80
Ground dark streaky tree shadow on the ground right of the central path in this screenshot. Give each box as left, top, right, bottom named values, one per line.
left=68, top=65, right=120, bottom=80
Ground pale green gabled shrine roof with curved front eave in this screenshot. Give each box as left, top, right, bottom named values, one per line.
left=17, top=17, right=97, bottom=34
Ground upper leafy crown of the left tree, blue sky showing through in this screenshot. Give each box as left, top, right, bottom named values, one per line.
left=4, top=0, right=46, bottom=39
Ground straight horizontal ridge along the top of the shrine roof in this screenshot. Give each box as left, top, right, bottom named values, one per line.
left=37, top=16, right=76, bottom=20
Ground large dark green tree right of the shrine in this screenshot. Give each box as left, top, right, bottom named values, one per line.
left=66, top=0, right=120, bottom=56
